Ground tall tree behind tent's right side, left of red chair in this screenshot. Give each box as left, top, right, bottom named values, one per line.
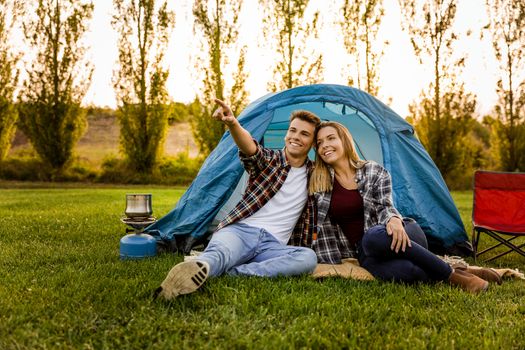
left=400, top=0, right=476, bottom=183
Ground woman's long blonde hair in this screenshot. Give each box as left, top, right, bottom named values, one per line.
left=308, top=121, right=365, bottom=194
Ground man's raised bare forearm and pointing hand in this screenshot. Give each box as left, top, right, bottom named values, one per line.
left=212, top=98, right=257, bottom=156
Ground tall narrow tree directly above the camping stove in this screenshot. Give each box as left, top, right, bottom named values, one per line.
left=112, top=0, right=175, bottom=173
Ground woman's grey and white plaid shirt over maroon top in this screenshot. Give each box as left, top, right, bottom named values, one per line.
left=312, top=161, right=402, bottom=264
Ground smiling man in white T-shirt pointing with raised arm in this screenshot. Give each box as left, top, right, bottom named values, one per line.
left=156, top=99, right=320, bottom=300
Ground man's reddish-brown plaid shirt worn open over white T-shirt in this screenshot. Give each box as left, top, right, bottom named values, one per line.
left=215, top=140, right=316, bottom=247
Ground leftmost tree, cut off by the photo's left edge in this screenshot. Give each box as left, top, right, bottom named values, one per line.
left=0, top=0, right=23, bottom=162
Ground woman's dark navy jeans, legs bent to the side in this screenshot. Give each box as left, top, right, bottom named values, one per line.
left=357, top=220, right=452, bottom=283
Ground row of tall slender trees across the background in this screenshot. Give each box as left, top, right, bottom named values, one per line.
left=0, top=0, right=525, bottom=187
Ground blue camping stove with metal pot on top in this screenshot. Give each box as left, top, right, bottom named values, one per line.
left=120, top=194, right=157, bottom=259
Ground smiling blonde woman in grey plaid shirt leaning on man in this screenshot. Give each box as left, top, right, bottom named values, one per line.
left=309, top=121, right=501, bottom=293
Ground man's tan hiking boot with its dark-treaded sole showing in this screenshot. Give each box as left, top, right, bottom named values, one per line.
left=154, top=260, right=210, bottom=300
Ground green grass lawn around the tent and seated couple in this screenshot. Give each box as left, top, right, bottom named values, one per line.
left=0, top=187, right=525, bottom=349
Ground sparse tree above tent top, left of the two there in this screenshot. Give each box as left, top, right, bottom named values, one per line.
left=260, top=0, right=323, bottom=91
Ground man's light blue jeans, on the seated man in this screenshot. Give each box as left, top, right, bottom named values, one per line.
left=197, top=223, right=317, bottom=277
